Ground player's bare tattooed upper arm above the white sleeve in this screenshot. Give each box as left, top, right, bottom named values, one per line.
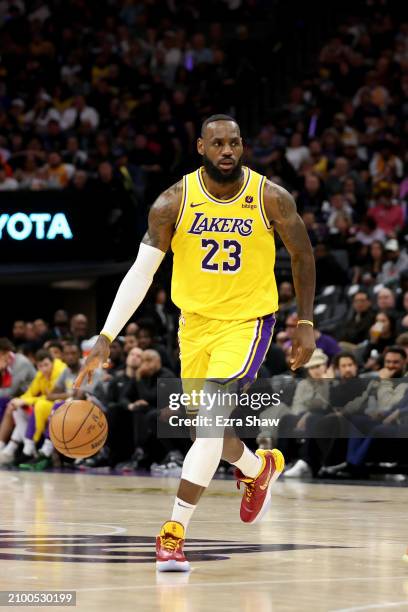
left=142, top=181, right=183, bottom=253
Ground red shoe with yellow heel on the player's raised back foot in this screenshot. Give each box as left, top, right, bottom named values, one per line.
left=235, top=448, right=285, bottom=523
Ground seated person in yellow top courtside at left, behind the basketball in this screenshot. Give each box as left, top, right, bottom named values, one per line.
left=0, top=350, right=66, bottom=465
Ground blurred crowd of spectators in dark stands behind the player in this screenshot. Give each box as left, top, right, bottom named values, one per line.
left=0, top=0, right=408, bottom=478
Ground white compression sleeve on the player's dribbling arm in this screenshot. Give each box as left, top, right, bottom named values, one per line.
left=101, top=243, right=165, bottom=342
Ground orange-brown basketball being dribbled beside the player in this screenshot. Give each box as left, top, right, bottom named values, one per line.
left=50, top=400, right=108, bottom=459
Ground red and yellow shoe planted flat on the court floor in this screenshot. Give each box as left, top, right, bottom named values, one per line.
left=156, top=521, right=190, bottom=572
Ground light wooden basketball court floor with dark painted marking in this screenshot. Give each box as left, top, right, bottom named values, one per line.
left=0, top=470, right=408, bottom=612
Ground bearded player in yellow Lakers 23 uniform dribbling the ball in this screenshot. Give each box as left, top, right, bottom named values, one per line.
left=76, top=115, right=315, bottom=571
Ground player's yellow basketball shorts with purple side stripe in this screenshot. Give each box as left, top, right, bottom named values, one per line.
left=179, top=313, right=275, bottom=386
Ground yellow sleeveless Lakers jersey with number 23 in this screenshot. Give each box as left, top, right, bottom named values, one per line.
left=171, top=167, right=278, bottom=320
